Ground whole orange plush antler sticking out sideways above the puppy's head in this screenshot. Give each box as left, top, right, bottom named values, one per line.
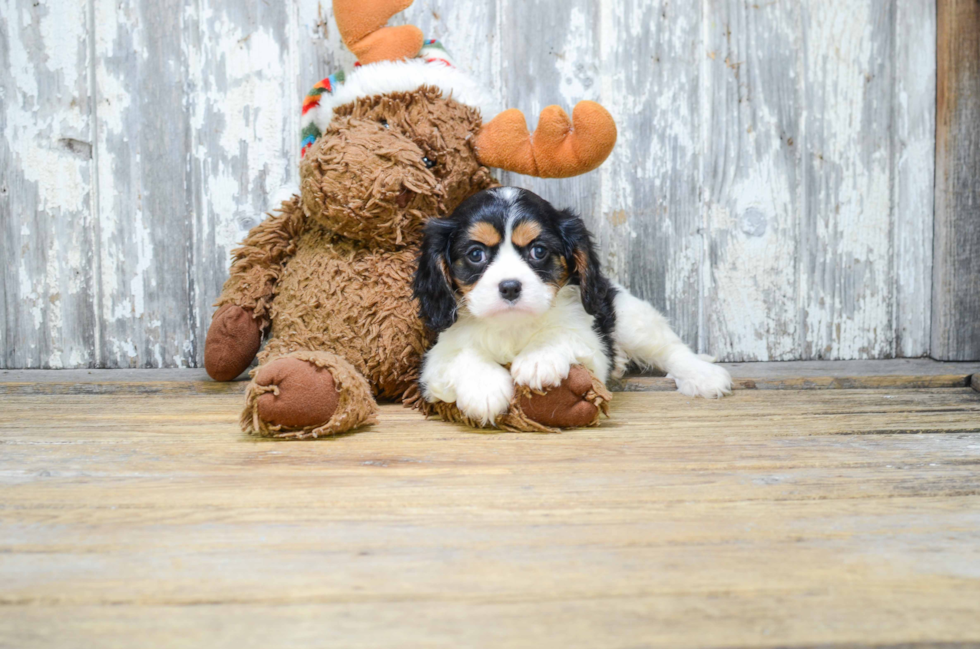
left=475, top=101, right=617, bottom=178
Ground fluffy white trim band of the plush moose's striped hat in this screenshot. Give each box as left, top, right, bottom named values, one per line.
left=303, top=59, right=495, bottom=131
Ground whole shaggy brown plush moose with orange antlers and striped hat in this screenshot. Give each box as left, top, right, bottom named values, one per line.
left=205, top=0, right=616, bottom=438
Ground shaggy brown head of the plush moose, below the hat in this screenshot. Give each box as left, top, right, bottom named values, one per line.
left=300, top=88, right=496, bottom=250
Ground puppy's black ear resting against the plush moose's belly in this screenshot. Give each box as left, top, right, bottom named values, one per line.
left=413, top=219, right=456, bottom=333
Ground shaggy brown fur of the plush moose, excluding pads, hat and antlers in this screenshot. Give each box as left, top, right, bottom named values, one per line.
left=208, top=88, right=609, bottom=439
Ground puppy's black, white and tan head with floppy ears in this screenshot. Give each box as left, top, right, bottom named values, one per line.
left=415, top=187, right=604, bottom=332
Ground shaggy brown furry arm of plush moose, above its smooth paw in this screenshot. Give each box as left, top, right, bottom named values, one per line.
left=215, top=196, right=306, bottom=330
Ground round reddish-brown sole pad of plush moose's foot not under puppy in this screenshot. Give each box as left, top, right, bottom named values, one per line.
left=255, top=358, right=340, bottom=428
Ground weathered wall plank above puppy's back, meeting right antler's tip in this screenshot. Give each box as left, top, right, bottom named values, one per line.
left=591, top=0, right=703, bottom=347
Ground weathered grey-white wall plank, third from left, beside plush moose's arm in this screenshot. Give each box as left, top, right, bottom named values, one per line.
left=186, top=0, right=300, bottom=367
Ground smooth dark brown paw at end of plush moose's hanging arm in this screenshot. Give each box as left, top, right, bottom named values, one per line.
left=204, top=304, right=262, bottom=381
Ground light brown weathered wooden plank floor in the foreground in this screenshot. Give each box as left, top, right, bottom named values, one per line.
left=0, top=362, right=980, bottom=649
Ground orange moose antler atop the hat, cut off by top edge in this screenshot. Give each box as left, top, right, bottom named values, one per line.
left=333, top=0, right=425, bottom=65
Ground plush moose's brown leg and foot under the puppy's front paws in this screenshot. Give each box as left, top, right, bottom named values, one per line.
left=421, top=365, right=612, bottom=433
